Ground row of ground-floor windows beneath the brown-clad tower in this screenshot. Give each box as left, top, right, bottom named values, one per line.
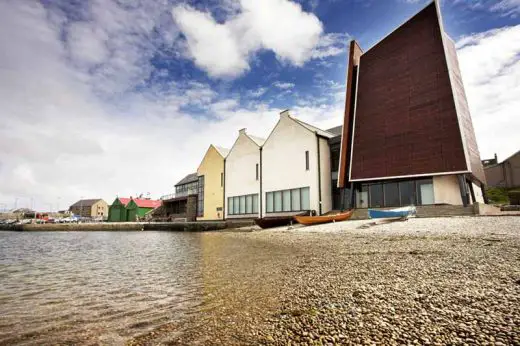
left=356, top=178, right=434, bottom=208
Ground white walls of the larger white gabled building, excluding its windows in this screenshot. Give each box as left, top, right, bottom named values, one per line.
left=262, top=114, right=332, bottom=216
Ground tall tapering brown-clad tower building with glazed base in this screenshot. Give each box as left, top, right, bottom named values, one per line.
left=338, top=1, right=485, bottom=208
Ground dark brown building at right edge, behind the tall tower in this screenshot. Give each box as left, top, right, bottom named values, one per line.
left=484, top=151, right=520, bottom=188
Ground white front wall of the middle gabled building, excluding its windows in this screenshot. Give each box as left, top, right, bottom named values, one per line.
left=225, top=133, right=260, bottom=218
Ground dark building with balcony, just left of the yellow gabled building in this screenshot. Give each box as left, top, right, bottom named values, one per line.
left=158, top=173, right=199, bottom=221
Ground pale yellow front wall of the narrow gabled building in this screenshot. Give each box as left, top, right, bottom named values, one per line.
left=197, top=146, right=224, bottom=220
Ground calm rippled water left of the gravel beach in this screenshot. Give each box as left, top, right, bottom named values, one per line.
left=0, top=232, right=202, bottom=345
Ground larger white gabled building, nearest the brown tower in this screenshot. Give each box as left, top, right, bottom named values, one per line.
left=261, top=110, right=334, bottom=217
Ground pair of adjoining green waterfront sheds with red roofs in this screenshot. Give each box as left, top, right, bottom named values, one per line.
left=108, top=197, right=161, bottom=222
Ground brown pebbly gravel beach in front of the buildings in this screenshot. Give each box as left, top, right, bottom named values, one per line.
left=165, top=217, right=520, bottom=345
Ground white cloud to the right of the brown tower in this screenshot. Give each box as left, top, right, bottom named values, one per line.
left=457, top=25, right=520, bottom=158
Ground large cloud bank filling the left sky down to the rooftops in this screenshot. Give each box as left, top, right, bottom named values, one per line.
left=0, top=1, right=341, bottom=209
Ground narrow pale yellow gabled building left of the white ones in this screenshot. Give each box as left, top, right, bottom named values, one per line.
left=197, top=145, right=229, bottom=220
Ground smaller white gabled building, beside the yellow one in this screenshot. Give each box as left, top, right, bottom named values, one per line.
left=224, top=129, right=264, bottom=219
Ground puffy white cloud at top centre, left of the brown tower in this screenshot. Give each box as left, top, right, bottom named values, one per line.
left=172, top=0, right=330, bottom=78
